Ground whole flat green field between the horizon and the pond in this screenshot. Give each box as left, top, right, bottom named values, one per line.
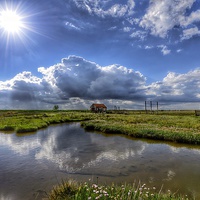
left=0, top=110, right=200, bottom=144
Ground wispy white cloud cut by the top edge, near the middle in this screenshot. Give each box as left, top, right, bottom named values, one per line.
left=74, top=0, right=135, bottom=17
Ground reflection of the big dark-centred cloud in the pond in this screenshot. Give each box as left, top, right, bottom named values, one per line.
left=35, top=124, right=147, bottom=175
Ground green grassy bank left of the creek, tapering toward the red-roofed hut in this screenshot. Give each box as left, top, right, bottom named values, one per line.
left=0, top=111, right=94, bottom=133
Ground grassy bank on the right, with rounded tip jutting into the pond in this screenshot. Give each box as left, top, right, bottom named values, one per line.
left=81, top=111, right=200, bottom=144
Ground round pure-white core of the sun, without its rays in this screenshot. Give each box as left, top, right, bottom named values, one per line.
left=0, top=10, right=24, bottom=33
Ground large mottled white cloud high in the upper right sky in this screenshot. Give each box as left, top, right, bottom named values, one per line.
left=140, top=0, right=195, bottom=38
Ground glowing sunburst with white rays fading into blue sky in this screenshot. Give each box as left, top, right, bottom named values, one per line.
left=0, top=3, right=42, bottom=51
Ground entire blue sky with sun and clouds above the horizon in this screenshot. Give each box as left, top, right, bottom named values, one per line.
left=0, top=0, right=200, bottom=109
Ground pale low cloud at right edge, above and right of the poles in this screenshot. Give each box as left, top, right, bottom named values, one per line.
left=148, top=69, right=200, bottom=102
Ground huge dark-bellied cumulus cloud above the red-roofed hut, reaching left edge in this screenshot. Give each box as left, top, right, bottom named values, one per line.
left=0, top=56, right=146, bottom=109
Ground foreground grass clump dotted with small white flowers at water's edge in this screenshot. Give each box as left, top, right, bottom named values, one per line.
left=48, top=181, right=188, bottom=200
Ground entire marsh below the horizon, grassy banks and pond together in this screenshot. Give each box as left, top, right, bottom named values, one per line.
left=0, top=110, right=200, bottom=199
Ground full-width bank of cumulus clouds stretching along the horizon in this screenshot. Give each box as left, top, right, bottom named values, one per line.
left=0, top=55, right=200, bottom=109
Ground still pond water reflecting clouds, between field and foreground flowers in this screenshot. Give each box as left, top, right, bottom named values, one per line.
left=0, top=123, right=200, bottom=200
